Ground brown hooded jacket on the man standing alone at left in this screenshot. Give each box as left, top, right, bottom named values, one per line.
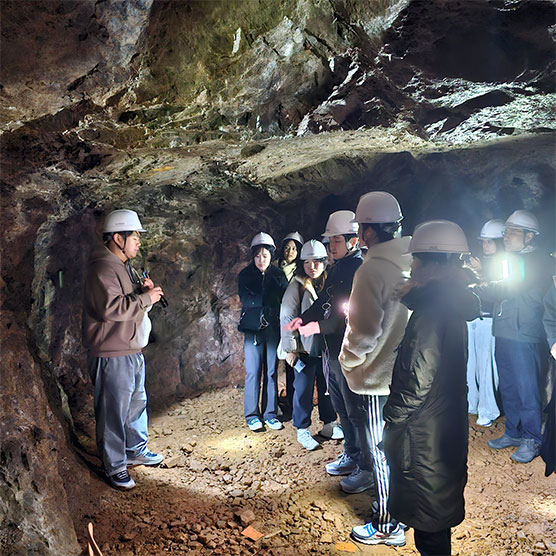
left=83, top=246, right=151, bottom=357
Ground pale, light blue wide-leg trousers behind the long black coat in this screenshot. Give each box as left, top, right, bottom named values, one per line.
left=467, top=317, right=500, bottom=421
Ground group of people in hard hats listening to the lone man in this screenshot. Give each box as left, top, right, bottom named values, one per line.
left=239, top=191, right=556, bottom=555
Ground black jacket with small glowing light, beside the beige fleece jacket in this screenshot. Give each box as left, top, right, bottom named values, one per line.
left=301, top=249, right=363, bottom=359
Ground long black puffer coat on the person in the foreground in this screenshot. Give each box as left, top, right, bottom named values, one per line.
left=383, top=269, right=479, bottom=532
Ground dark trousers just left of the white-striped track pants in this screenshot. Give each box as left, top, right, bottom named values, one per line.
left=328, top=359, right=373, bottom=471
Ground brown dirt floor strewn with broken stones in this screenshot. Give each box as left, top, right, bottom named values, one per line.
left=79, top=388, right=556, bottom=556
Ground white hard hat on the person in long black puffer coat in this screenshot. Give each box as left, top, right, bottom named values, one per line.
left=407, top=220, right=469, bottom=253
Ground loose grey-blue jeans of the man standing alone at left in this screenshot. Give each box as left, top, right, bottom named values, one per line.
left=87, top=353, right=148, bottom=475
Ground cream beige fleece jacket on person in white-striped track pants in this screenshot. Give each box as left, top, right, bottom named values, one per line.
left=339, top=236, right=411, bottom=396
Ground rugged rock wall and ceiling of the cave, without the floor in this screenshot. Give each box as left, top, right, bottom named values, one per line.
left=0, top=0, right=556, bottom=554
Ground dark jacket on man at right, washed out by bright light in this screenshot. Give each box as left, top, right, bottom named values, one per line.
left=477, top=251, right=550, bottom=343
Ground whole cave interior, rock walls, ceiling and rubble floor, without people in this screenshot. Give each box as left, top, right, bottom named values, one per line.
left=0, top=0, right=556, bottom=556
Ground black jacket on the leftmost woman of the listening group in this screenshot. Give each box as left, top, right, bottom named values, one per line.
left=238, top=262, right=288, bottom=333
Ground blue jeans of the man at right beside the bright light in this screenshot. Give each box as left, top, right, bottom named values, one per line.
left=495, top=338, right=542, bottom=444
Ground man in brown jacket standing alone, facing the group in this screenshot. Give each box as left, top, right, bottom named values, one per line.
left=83, top=210, right=164, bottom=490
